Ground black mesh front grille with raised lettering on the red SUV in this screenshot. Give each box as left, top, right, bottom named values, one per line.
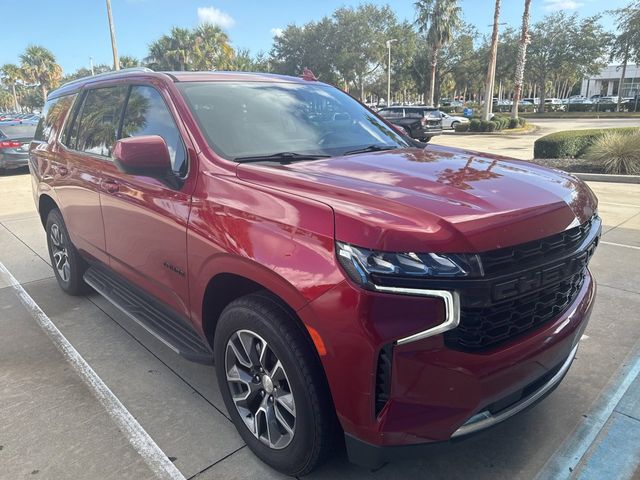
left=445, top=219, right=600, bottom=351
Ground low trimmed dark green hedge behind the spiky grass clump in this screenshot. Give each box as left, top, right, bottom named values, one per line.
left=533, top=127, right=640, bottom=158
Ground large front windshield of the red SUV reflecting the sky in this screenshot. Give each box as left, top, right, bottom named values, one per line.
left=177, top=82, right=409, bottom=161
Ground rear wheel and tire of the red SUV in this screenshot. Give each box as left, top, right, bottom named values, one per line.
left=45, top=209, right=89, bottom=295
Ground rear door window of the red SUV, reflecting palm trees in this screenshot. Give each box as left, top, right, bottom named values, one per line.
left=71, top=85, right=129, bottom=157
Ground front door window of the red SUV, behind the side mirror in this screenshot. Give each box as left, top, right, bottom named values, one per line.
left=121, top=85, right=187, bottom=176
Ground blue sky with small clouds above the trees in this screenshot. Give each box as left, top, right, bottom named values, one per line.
left=0, top=0, right=629, bottom=73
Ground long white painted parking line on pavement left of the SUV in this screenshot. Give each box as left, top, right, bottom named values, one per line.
left=0, top=262, right=185, bottom=480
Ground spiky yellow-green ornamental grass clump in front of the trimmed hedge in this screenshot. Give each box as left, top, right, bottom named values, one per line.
left=584, top=130, right=640, bottom=175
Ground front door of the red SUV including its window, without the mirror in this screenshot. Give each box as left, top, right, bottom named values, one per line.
left=101, top=84, right=195, bottom=317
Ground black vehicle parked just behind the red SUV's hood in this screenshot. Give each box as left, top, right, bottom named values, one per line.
left=378, top=106, right=442, bottom=142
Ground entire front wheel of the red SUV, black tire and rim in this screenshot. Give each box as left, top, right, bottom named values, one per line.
left=214, top=292, right=337, bottom=476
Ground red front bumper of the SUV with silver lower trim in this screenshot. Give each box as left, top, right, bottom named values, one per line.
left=300, top=272, right=596, bottom=463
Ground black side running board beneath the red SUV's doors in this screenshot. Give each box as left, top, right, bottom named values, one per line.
left=84, top=265, right=213, bottom=364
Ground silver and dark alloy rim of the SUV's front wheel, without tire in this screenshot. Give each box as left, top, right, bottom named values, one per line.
left=225, top=330, right=296, bottom=450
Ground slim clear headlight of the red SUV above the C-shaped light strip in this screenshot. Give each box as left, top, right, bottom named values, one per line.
left=336, top=242, right=482, bottom=287
